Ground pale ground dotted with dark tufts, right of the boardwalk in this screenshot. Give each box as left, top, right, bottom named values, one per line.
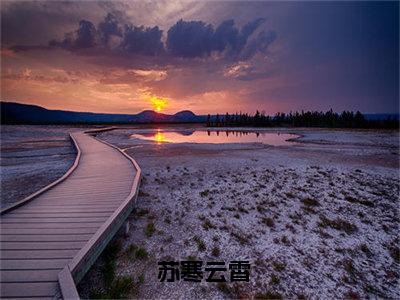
left=80, top=129, right=400, bottom=299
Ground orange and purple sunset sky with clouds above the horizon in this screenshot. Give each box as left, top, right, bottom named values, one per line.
left=1, top=1, right=399, bottom=114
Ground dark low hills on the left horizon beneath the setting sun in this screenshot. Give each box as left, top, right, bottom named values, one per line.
left=0, top=102, right=207, bottom=124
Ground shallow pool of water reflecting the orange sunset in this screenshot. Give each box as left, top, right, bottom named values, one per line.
left=130, top=129, right=297, bottom=146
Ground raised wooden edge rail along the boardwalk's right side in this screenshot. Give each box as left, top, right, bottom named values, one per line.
left=58, top=127, right=142, bottom=299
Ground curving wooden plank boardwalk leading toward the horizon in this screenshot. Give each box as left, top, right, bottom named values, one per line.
left=0, top=132, right=140, bottom=298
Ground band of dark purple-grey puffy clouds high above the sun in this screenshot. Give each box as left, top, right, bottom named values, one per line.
left=10, top=10, right=276, bottom=60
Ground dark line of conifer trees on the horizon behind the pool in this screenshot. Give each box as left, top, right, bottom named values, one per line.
left=207, top=109, right=399, bottom=128
